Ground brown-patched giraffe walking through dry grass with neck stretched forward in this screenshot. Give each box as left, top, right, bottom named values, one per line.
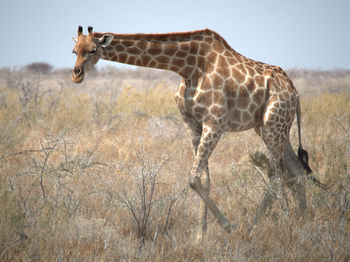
left=72, top=26, right=318, bottom=239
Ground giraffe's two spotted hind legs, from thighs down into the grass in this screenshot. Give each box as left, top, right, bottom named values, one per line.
left=255, top=92, right=307, bottom=222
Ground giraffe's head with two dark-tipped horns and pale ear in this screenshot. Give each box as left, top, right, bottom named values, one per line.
left=72, top=26, right=113, bottom=83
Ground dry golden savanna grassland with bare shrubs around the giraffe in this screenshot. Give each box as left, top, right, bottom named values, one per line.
left=0, top=65, right=350, bottom=261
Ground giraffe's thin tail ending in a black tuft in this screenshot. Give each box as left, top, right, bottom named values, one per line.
left=297, top=96, right=328, bottom=189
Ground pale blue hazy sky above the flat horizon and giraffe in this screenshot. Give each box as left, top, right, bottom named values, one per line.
left=0, top=0, right=350, bottom=69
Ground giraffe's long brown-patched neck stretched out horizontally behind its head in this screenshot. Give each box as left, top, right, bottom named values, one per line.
left=94, top=30, right=213, bottom=78
